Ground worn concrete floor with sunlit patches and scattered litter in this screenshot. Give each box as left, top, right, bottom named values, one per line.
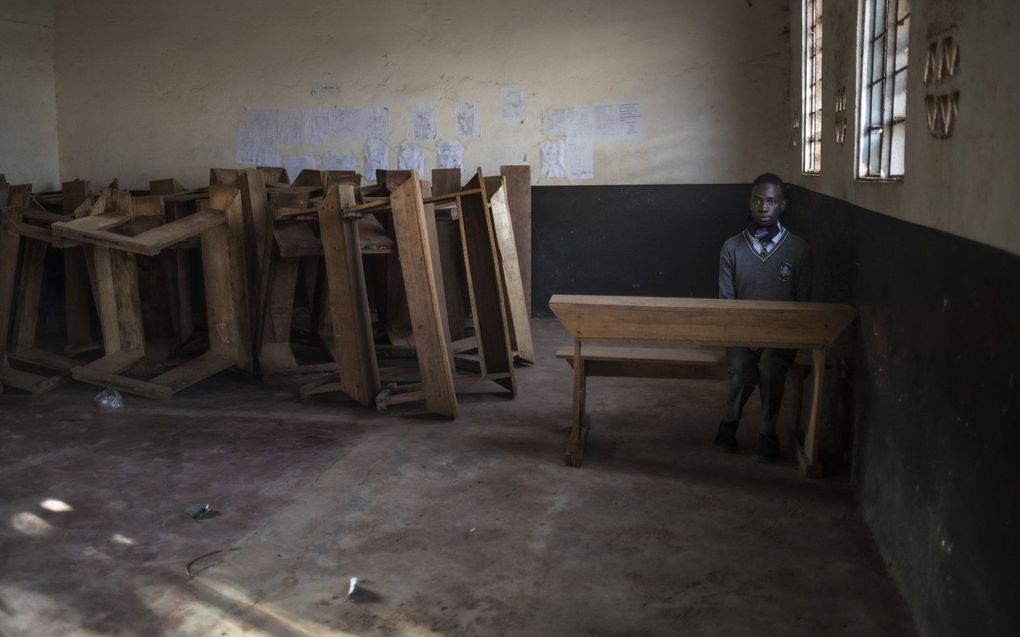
left=0, top=320, right=914, bottom=636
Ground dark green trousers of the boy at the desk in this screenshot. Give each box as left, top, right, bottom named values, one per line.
left=723, top=348, right=797, bottom=433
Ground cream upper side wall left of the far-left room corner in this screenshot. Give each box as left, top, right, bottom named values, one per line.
left=0, top=0, right=60, bottom=192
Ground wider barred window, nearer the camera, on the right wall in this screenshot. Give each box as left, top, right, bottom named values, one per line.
left=857, top=0, right=910, bottom=179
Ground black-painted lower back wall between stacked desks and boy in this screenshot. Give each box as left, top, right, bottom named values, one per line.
left=531, top=184, right=750, bottom=316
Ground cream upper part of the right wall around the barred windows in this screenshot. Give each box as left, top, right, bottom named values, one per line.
left=788, top=0, right=1020, bottom=255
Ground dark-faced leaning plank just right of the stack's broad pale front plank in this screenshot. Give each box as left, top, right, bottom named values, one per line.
left=460, top=169, right=516, bottom=393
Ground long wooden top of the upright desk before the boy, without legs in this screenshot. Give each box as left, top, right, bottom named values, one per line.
left=549, top=295, right=857, bottom=348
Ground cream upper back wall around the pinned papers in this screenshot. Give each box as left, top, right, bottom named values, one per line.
left=56, top=0, right=789, bottom=187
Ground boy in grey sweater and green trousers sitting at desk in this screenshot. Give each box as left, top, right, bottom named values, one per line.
left=715, top=172, right=811, bottom=462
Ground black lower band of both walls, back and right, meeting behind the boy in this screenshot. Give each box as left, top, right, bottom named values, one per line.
left=532, top=184, right=1020, bottom=635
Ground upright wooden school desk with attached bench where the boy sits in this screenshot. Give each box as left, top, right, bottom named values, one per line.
left=549, top=295, right=857, bottom=477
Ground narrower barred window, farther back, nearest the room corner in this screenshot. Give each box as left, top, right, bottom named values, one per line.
left=802, top=0, right=822, bottom=174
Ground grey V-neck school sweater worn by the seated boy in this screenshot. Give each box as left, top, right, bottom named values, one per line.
left=719, top=230, right=811, bottom=301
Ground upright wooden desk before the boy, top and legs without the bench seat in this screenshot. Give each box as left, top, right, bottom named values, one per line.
left=549, top=295, right=857, bottom=477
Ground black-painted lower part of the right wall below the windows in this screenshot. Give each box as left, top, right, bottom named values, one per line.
left=788, top=188, right=1020, bottom=635
